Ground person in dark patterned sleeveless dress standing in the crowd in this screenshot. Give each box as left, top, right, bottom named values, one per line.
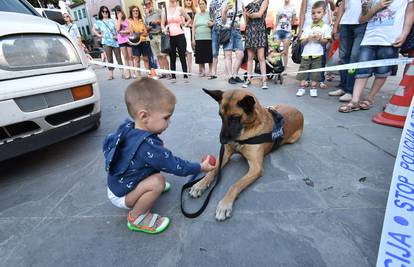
left=243, top=0, right=269, bottom=89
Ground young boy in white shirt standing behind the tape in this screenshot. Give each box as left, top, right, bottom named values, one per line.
left=296, top=1, right=331, bottom=97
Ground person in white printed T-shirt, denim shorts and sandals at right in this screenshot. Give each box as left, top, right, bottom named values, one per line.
left=338, top=0, right=414, bottom=113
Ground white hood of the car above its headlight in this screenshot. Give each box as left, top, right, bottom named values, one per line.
left=0, top=12, right=60, bottom=36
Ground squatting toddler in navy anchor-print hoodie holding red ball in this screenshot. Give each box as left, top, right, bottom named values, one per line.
left=103, top=78, right=214, bottom=234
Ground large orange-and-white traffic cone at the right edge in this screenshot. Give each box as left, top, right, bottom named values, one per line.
left=372, top=62, right=414, bottom=128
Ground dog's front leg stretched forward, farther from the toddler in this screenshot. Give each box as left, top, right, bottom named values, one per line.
left=216, top=153, right=264, bottom=221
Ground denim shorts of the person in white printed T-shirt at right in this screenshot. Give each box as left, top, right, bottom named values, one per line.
left=355, top=45, right=398, bottom=79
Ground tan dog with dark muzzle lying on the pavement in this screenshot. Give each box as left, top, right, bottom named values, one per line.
left=190, top=89, right=303, bottom=221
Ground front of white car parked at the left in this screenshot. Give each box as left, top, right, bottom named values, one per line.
left=0, top=7, right=101, bottom=161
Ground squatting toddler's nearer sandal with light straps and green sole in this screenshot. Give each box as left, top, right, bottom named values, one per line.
left=127, top=213, right=170, bottom=234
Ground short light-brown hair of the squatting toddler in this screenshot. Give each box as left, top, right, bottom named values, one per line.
left=125, top=78, right=176, bottom=119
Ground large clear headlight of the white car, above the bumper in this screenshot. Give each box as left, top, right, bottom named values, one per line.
left=0, top=34, right=81, bottom=70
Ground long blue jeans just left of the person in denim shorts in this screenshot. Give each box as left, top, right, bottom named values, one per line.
left=339, top=23, right=367, bottom=94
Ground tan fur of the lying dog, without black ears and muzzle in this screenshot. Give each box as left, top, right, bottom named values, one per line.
left=190, top=90, right=303, bottom=221
